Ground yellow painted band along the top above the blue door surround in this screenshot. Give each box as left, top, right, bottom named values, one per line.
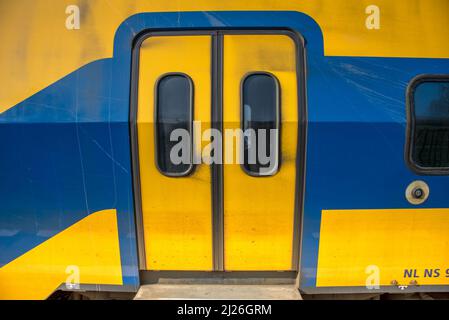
left=0, top=0, right=449, bottom=112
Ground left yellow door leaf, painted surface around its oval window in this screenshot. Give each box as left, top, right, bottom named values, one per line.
left=137, top=36, right=212, bottom=270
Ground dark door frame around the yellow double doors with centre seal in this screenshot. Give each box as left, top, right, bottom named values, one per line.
left=129, top=27, right=308, bottom=272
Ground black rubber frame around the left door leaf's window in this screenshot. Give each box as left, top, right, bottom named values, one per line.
left=153, top=72, right=195, bottom=178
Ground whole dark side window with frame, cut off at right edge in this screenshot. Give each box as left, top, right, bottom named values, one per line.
left=408, top=76, right=449, bottom=174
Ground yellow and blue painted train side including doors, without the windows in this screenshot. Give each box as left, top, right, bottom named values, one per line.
left=0, top=0, right=449, bottom=299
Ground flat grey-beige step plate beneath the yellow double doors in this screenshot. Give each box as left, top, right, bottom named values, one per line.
left=134, top=284, right=302, bottom=300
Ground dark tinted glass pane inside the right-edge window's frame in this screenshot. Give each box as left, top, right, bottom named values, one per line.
left=412, top=80, right=449, bottom=168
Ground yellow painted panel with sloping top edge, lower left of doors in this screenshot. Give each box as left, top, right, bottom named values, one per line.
left=0, top=209, right=123, bottom=299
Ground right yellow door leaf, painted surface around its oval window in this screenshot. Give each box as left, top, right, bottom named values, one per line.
left=223, top=35, right=298, bottom=270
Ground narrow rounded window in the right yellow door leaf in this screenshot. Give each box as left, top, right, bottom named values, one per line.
left=241, top=72, right=280, bottom=176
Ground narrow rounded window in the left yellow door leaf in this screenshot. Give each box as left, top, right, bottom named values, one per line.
left=155, top=73, right=193, bottom=177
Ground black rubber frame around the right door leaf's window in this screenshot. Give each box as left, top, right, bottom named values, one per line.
left=240, top=71, right=282, bottom=178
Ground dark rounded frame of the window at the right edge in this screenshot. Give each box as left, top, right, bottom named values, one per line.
left=405, top=74, right=449, bottom=175
